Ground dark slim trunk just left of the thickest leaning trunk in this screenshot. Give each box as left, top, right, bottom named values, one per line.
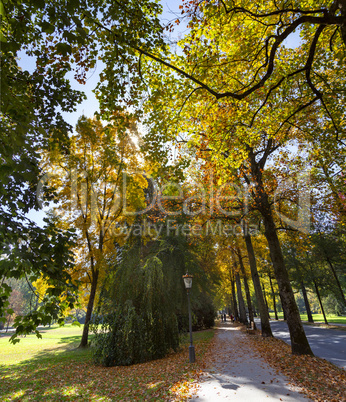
left=243, top=227, right=273, bottom=338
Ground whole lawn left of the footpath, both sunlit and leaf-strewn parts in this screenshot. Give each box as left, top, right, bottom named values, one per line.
left=0, top=325, right=214, bottom=402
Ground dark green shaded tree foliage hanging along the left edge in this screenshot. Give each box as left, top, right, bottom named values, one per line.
left=0, top=1, right=88, bottom=334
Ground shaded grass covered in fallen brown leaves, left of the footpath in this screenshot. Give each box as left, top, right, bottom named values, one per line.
left=0, top=337, right=212, bottom=402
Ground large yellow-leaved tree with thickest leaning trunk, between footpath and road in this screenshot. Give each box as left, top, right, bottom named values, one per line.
left=5, top=0, right=345, bottom=353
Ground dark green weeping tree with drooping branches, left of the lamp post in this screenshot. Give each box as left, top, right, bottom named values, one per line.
left=93, top=239, right=182, bottom=366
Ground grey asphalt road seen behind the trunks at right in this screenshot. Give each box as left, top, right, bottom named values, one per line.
left=256, top=319, right=346, bottom=369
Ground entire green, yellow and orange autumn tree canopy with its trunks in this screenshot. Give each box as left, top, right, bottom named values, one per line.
left=0, top=0, right=346, bottom=354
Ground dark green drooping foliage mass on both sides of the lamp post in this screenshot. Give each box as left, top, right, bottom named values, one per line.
left=94, top=209, right=215, bottom=366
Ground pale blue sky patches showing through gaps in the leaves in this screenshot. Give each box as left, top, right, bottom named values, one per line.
left=24, top=0, right=299, bottom=226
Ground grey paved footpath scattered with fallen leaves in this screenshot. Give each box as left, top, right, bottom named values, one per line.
left=191, top=322, right=310, bottom=402
